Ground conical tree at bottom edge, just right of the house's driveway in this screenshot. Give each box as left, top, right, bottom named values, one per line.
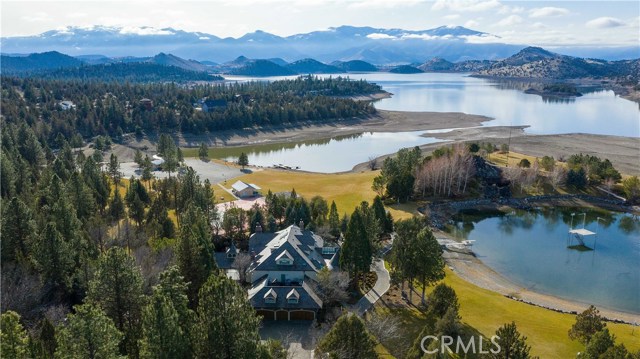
left=315, top=314, right=378, bottom=359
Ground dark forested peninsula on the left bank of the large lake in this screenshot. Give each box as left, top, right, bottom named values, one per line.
left=2, top=77, right=381, bottom=146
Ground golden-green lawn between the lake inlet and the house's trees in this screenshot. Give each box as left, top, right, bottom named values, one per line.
left=226, top=169, right=417, bottom=219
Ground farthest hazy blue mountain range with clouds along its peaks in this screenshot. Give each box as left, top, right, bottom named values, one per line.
left=0, top=26, right=640, bottom=64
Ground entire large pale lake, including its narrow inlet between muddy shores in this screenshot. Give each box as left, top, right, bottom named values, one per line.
left=219, top=72, right=640, bottom=172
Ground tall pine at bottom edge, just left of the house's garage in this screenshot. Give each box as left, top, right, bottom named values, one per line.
left=194, top=273, right=260, bottom=358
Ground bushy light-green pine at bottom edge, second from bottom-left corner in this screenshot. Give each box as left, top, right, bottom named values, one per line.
left=55, top=304, right=122, bottom=359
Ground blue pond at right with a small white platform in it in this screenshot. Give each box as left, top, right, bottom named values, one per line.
left=449, top=207, right=640, bottom=314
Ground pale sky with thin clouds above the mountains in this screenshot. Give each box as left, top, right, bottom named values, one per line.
left=0, top=0, right=640, bottom=46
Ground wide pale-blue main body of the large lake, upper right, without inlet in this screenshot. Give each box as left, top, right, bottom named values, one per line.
left=364, top=74, right=640, bottom=137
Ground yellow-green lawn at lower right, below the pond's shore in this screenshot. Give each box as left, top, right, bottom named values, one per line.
left=379, top=269, right=640, bottom=358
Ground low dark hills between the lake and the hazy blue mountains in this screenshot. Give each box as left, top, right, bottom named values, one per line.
left=1, top=47, right=640, bottom=83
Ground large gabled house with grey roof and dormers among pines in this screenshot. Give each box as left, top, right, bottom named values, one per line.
left=217, top=223, right=339, bottom=320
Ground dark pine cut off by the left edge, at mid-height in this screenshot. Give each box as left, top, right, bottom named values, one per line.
left=0, top=197, right=35, bottom=262
